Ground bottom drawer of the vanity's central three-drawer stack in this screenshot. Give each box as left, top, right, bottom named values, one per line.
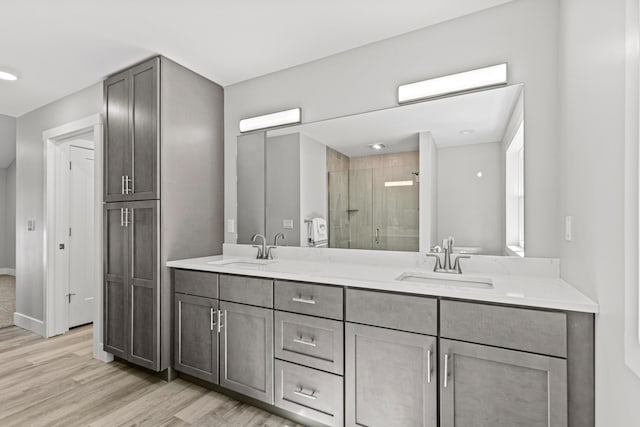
left=275, top=360, right=344, bottom=427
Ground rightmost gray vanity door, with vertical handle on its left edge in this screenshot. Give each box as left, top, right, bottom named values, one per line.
left=440, top=339, right=567, bottom=427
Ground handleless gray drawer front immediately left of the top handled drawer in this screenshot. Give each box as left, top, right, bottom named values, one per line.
left=220, top=274, right=273, bottom=308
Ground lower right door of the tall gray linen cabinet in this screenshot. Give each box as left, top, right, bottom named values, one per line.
left=126, top=200, right=160, bottom=371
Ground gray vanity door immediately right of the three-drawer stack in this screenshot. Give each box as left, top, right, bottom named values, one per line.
left=345, top=323, right=438, bottom=427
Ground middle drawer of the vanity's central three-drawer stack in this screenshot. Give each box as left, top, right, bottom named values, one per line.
left=275, top=311, right=344, bottom=375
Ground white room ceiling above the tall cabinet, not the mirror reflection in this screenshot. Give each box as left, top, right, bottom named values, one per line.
left=0, top=0, right=511, bottom=116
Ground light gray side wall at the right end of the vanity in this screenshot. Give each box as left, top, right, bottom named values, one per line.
left=556, top=0, right=640, bottom=427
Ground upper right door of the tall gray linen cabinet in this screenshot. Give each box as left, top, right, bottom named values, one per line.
left=129, top=58, right=160, bottom=200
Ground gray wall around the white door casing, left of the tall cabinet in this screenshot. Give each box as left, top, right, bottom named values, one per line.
left=16, top=83, right=102, bottom=320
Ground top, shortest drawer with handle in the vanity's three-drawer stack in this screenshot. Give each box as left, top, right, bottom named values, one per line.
left=274, top=280, right=343, bottom=320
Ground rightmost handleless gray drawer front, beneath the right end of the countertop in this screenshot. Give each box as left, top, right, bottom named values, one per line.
left=440, top=300, right=567, bottom=357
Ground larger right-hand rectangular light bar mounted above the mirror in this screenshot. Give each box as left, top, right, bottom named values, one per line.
left=398, top=63, right=507, bottom=104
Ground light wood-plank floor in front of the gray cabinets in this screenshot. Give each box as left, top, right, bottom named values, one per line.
left=0, top=326, right=299, bottom=427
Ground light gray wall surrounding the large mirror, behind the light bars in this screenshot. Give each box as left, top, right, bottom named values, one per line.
left=225, top=0, right=560, bottom=257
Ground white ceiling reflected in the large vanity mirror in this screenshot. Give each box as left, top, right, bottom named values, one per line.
left=268, top=85, right=523, bottom=157
